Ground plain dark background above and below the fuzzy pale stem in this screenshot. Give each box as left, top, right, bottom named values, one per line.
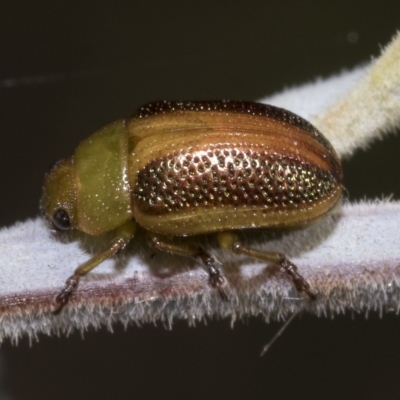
left=0, top=0, right=400, bottom=400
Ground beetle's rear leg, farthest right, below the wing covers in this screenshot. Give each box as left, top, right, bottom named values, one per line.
left=217, top=231, right=317, bottom=300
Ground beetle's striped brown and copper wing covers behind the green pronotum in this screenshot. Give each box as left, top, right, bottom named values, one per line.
left=128, top=102, right=342, bottom=235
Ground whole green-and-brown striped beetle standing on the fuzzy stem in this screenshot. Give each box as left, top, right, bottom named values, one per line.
left=41, top=101, right=343, bottom=311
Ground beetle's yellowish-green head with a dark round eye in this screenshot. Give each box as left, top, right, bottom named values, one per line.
left=40, top=157, right=77, bottom=231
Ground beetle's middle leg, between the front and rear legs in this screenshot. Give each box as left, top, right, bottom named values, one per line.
left=148, top=233, right=228, bottom=301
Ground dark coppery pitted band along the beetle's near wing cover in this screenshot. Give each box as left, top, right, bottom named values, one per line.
left=133, top=148, right=337, bottom=214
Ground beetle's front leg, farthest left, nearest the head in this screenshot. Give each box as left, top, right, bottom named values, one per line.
left=53, top=221, right=136, bottom=314
